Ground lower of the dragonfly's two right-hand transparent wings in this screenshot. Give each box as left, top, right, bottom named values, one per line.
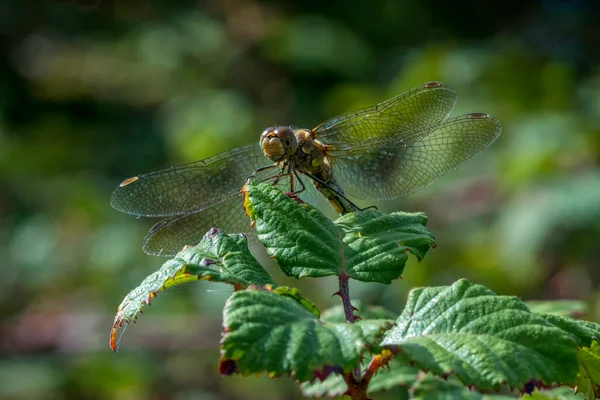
left=330, top=113, right=502, bottom=200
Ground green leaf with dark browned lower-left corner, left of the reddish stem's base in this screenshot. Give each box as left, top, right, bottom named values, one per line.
left=221, top=288, right=391, bottom=382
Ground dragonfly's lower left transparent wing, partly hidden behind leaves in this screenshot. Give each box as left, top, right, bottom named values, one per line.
left=143, top=169, right=316, bottom=257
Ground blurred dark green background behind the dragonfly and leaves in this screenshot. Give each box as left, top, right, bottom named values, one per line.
left=0, top=0, right=600, bottom=400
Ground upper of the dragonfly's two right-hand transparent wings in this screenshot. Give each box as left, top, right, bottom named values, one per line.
left=313, top=82, right=457, bottom=145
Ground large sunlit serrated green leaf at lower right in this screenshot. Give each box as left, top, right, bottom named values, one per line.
left=381, top=280, right=577, bottom=390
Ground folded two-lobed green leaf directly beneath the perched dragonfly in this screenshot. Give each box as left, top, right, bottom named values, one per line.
left=244, top=181, right=435, bottom=283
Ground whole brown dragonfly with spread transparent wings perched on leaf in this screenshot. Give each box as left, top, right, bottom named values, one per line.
left=111, top=81, right=502, bottom=256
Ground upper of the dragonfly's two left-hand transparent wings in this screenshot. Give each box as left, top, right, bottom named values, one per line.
left=110, top=143, right=269, bottom=217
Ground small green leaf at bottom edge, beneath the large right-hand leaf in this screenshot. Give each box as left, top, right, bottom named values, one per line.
left=411, top=375, right=514, bottom=400
